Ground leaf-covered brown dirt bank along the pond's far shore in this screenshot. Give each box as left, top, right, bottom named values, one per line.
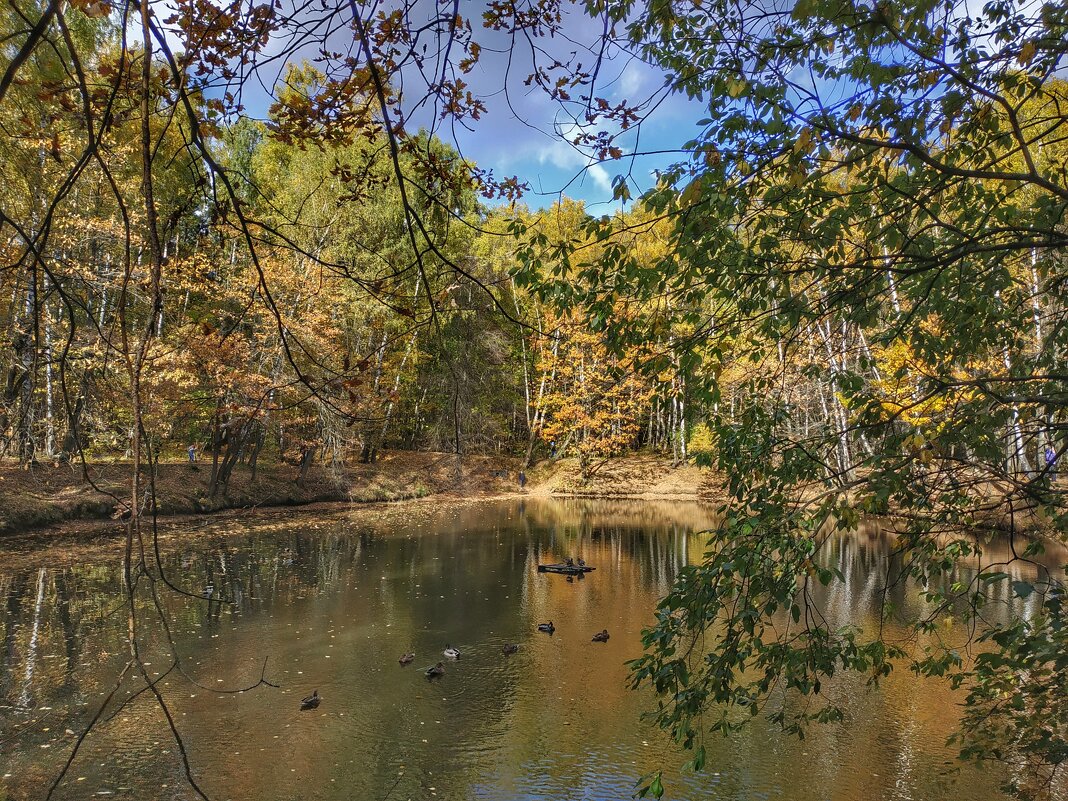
left=0, top=452, right=717, bottom=534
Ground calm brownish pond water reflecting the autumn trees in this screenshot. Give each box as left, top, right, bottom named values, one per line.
left=0, top=500, right=1064, bottom=801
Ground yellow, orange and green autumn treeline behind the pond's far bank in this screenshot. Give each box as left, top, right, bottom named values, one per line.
left=6, top=36, right=1064, bottom=495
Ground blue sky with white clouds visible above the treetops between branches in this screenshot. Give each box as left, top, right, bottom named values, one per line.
left=173, top=0, right=706, bottom=214
